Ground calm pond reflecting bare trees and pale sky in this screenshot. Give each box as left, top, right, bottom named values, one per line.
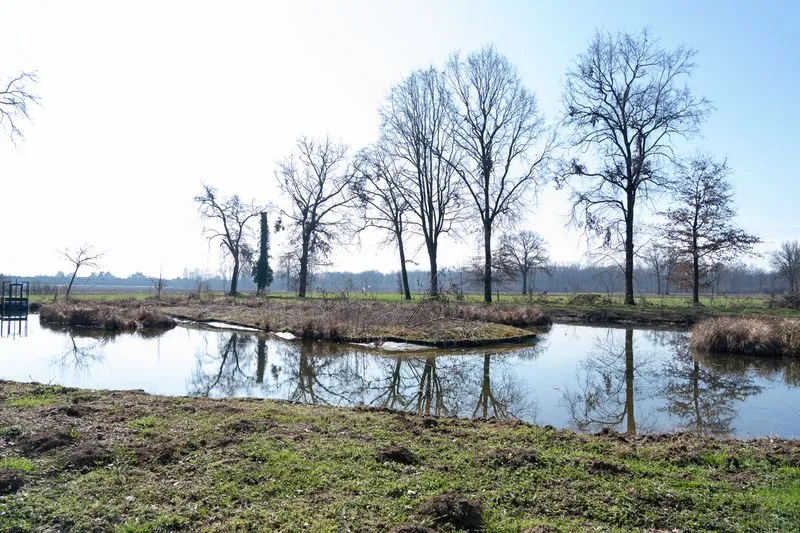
left=0, top=314, right=800, bottom=438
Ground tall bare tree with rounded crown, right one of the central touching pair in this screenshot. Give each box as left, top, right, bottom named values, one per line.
left=447, top=46, right=552, bottom=302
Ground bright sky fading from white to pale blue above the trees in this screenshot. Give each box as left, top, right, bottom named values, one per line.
left=0, top=0, right=800, bottom=277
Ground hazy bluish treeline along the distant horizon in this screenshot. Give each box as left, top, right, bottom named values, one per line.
left=0, top=264, right=788, bottom=295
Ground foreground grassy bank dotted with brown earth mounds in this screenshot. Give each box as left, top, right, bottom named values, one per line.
left=0, top=382, right=800, bottom=532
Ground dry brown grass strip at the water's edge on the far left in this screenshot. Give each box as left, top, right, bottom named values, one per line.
left=39, top=302, right=176, bottom=331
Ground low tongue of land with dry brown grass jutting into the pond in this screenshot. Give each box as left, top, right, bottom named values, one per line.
left=155, top=298, right=550, bottom=346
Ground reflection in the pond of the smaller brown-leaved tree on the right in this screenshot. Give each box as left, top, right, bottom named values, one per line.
left=661, top=332, right=762, bottom=435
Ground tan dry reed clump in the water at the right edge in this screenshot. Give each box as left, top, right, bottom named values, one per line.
left=691, top=318, right=800, bottom=357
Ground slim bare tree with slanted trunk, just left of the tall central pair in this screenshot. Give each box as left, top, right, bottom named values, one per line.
left=352, top=142, right=411, bottom=300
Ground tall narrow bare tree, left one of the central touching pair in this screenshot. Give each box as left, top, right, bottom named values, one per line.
left=381, top=67, right=461, bottom=297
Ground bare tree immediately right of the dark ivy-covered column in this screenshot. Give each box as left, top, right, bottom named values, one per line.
left=277, top=137, right=354, bottom=298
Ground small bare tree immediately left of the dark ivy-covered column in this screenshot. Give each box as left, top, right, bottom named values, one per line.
left=194, top=183, right=263, bottom=296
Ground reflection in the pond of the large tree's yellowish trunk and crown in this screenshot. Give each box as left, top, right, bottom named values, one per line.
left=564, top=328, right=650, bottom=435
